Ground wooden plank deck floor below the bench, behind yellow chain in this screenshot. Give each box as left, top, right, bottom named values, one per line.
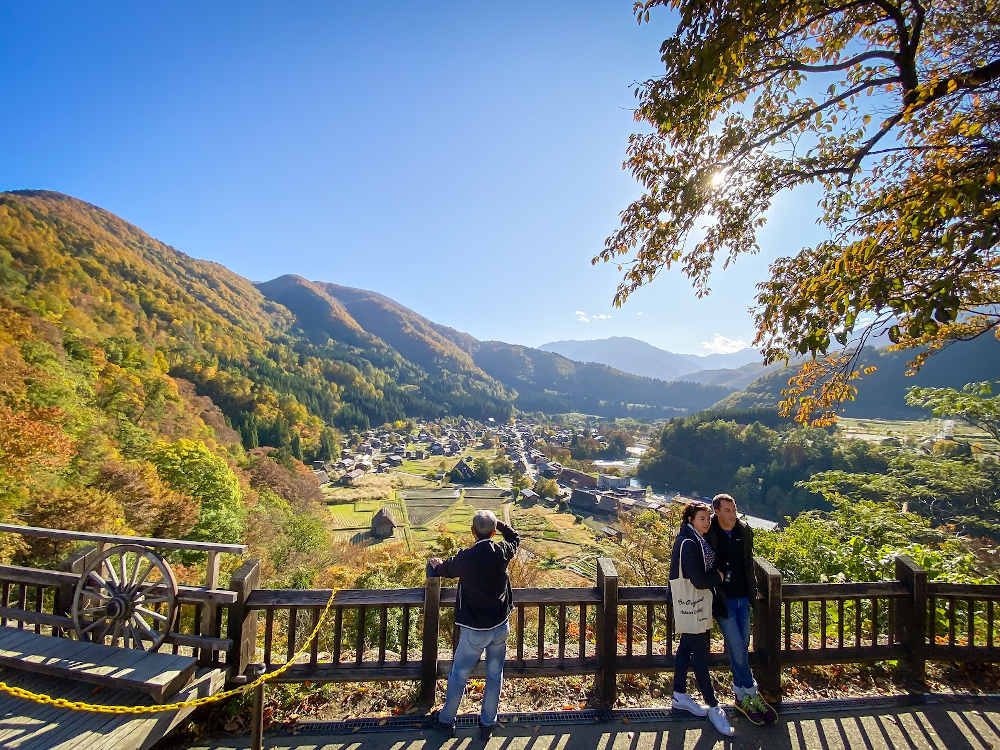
left=0, top=669, right=225, bottom=750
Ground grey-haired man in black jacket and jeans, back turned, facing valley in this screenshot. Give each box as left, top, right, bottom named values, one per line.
left=427, top=510, right=521, bottom=741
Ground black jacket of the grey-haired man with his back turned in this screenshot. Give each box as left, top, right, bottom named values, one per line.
left=433, top=521, right=521, bottom=630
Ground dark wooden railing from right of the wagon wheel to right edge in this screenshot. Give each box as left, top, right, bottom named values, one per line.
left=240, top=556, right=1000, bottom=720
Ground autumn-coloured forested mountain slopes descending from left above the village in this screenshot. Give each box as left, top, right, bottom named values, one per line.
left=0, top=191, right=724, bottom=488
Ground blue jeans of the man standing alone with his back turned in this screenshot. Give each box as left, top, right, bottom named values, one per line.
left=438, top=622, right=510, bottom=727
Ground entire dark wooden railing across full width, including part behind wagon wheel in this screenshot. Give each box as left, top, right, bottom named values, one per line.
left=0, top=525, right=1000, bottom=724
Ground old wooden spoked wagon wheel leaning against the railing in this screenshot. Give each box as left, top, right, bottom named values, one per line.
left=72, top=544, right=177, bottom=651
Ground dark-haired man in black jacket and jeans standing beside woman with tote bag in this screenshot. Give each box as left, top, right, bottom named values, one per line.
left=705, top=494, right=778, bottom=726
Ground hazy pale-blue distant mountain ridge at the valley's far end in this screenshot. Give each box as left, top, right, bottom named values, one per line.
left=538, top=336, right=761, bottom=382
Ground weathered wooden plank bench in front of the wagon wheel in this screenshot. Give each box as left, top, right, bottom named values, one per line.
left=0, top=627, right=197, bottom=703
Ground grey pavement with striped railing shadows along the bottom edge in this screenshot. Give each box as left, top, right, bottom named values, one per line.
left=188, top=698, right=1000, bottom=750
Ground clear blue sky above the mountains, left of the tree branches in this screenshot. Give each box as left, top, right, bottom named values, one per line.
left=0, top=0, right=818, bottom=354
